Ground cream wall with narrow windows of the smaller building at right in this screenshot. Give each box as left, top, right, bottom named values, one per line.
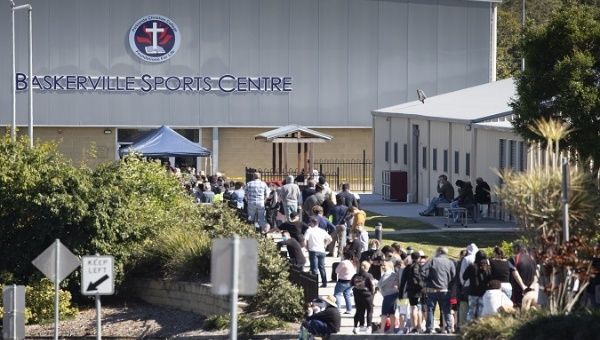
left=373, top=116, right=528, bottom=204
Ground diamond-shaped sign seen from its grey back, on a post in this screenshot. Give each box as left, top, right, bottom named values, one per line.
left=31, top=239, right=81, bottom=340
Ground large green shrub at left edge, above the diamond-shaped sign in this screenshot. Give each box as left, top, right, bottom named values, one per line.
left=0, top=136, right=92, bottom=284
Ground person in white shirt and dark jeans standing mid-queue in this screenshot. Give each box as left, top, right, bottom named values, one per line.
left=304, top=216, right=332, bottom=287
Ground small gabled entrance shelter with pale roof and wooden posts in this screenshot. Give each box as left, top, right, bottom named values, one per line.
left=254, top=125, right=333, bottom=174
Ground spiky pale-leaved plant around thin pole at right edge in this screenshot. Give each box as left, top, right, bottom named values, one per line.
left=496, top=119, right=600, bottom=313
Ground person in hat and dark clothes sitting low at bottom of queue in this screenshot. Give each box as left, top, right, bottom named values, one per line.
left=302, top=295, right=342, bottom=336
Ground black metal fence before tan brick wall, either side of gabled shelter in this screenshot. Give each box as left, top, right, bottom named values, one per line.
left=246, top=153, right=373, bottom=192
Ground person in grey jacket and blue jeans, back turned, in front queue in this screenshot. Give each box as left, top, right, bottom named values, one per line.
left=423, top=247, right=456, bottom=333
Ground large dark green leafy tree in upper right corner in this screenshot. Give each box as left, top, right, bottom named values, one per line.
left=511, top=5, right=600, bottom=168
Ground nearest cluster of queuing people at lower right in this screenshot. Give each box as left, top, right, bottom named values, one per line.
left=302, top=240, right=539, bottom=334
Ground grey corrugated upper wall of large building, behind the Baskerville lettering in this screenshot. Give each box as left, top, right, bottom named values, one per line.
left=0, top=0, right=491, bottom=128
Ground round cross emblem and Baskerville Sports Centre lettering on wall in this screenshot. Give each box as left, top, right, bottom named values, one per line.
left=15, top=15, right=292, bottom=93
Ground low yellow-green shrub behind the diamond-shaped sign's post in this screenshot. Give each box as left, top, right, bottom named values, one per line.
left=0, top=279, right=79, bottom=324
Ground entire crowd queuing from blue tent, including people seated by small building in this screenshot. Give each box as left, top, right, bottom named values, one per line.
left=164, top=165, right=538, bottom=335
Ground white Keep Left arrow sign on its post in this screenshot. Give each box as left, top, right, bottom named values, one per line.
left=81, top=255, right=115, bottom=340
